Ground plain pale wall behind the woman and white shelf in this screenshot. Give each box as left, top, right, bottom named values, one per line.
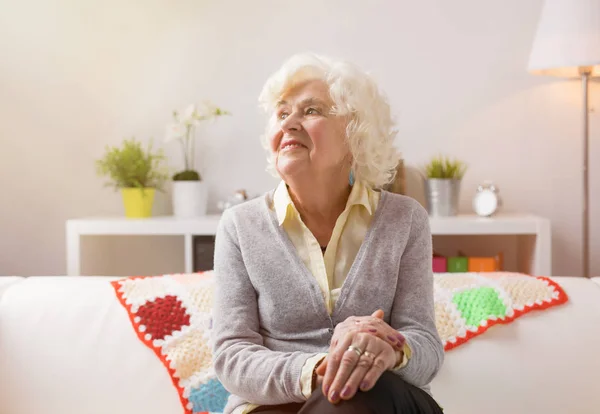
left=0, top=0, right=600, bottom=275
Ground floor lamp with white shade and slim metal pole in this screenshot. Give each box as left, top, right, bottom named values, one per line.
left=528, top=0, right=600, bottom=277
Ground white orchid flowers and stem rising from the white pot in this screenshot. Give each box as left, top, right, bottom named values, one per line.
left=165, top=101, right=231, bottom=181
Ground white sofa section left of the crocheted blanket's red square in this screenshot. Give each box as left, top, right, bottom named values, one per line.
left=0, top=276, right=181, bottom=414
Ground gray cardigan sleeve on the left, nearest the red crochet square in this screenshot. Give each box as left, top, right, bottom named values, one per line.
left=212, top=210, right=324, bottom=405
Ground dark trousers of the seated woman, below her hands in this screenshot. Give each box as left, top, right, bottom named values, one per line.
left=252, top=372, right=443, bottom=414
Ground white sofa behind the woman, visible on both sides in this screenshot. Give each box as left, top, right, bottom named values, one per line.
left=0, top=276, right=600, bottom=414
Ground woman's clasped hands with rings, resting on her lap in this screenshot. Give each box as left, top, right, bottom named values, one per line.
left=315, top=310, right=405, bottom=404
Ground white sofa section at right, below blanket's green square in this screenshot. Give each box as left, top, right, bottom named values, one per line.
left=431, top=277, right=600, bottom=414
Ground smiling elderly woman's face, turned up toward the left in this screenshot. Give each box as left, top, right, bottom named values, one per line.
left=269, top=80, right=349, bottom=178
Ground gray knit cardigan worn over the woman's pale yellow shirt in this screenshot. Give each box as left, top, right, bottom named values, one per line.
left=212, top=191, right=444, bottom=414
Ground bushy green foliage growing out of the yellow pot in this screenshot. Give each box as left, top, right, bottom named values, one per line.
left=96, top=138, right=169, bottom=191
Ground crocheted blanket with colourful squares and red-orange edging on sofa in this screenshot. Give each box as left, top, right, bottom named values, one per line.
left=111, top=272, right=568, bottom=414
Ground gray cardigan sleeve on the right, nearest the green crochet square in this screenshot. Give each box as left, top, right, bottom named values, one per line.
left=390, top=200, right=444, bottom=387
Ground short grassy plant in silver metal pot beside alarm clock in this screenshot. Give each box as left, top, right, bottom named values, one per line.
left=425, top=156, right=467, bottom=217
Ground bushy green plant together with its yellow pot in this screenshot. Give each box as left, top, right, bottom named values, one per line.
left=96, top=138, right=169, bottom=218
